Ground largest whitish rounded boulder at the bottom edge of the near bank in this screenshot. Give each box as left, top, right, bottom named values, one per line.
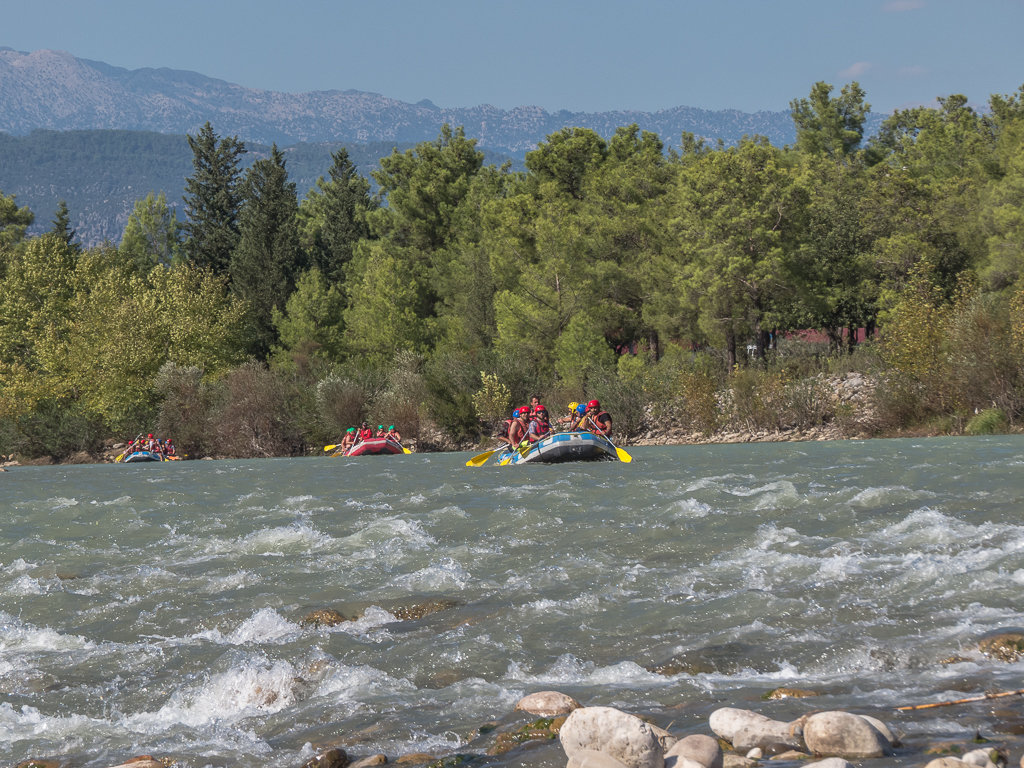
left=558, top=707, right=665, bottom=768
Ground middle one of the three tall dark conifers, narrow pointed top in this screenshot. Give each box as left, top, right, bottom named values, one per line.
left=230, top=144, right=305, bottom=358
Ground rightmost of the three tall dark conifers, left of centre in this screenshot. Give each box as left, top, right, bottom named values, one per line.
left=299, top=147, right=377, bottom=285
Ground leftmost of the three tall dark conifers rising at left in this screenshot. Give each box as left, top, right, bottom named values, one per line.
left=184, top=122, right=246, bottom=274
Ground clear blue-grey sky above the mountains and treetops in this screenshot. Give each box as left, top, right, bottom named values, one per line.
left=0, top=0, right=1024, bottom=113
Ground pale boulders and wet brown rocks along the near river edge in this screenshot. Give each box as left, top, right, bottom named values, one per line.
left=15, top=626, right=1024, bottom=768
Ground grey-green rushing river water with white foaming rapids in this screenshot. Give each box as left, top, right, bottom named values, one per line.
left=0, top=437, right=1024, bottom=768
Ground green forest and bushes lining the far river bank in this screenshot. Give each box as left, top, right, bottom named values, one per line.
left=0, top=83, right=1024, bottom=456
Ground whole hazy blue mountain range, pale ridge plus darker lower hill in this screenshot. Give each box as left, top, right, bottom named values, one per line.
left=0, top=47, right=876, bottom=244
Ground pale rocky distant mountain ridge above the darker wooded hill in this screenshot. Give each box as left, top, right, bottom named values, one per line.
left=0, top=48, right=798, bottom=152
